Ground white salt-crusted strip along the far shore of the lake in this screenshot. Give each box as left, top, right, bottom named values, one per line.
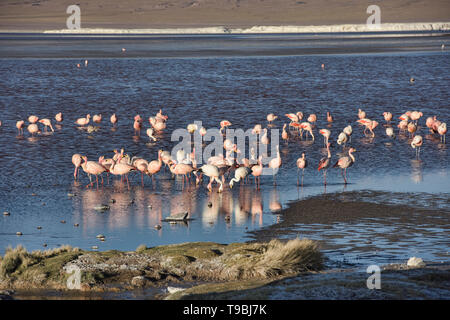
left=0, top=22, right=450, bottom=35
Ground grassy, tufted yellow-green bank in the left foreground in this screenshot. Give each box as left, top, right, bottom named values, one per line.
left=0, top=239, right=323, bottom=297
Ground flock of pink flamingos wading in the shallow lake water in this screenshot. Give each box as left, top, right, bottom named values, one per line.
left=0, top=109, right=447, bottom=192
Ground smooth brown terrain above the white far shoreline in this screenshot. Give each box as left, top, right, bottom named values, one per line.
left=0, top=0, right=450, bottom=31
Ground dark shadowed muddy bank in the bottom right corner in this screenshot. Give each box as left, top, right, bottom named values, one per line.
left=166, top=264, right=450, bottom=300
